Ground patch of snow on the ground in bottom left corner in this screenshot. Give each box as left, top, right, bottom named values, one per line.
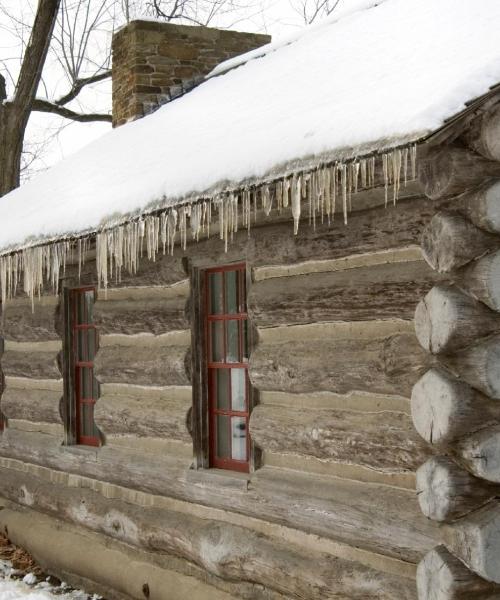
left=0, top=560, right=97, bottom=600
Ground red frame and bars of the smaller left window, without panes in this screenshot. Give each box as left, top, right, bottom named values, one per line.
left=70, top=286, right=101, bottom=446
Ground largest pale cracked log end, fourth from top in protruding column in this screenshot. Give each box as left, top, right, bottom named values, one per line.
left=411, top=368, right=500, bottom=444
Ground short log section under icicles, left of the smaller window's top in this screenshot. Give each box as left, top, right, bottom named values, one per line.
left=1, top=296, right=60, bottom=342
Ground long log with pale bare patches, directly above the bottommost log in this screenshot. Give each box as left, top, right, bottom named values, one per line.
left=0, top=469, right=415, bottom=600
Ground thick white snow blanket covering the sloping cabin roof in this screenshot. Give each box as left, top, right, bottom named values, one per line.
left=0, top=0, right=500, bottom=252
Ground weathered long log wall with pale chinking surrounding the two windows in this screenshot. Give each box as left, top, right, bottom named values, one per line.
left=0, top=185, right=449, bottom=600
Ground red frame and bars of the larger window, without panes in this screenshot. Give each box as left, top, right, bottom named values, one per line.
left=204, top=263, right=251, bottom=473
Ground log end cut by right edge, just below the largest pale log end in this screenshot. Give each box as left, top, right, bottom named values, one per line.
left=455, top=425, right=500, bottom=483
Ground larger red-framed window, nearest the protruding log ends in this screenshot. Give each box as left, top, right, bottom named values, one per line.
left=205, top=264, right=250, bottom=472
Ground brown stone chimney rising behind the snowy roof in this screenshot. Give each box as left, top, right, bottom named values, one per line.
left=112, top=21, right=271, bottom=127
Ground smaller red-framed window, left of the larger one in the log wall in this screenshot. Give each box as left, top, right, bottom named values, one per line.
left=68, top=287, right=100, bottom=446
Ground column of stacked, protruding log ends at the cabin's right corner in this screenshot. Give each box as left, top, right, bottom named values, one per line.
left=411, top=109, right=500, bottom=600
